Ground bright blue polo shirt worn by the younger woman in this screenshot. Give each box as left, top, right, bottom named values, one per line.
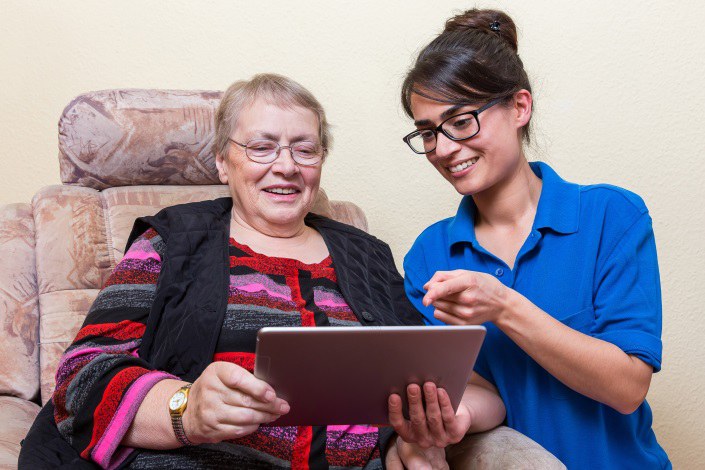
left=404, top=163, right=671, bottom=470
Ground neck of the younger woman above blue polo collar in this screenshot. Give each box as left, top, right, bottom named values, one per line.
left=473, top=158, right=541, bottom=227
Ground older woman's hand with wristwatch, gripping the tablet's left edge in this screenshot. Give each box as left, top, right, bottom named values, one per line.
left=183, top=362, right=289, bottom=444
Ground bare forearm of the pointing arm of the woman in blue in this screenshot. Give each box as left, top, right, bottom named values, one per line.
left=497, top=293, right=651, bottom=413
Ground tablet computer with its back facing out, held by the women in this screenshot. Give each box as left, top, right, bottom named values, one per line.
left=254, top=326, right=486, bottom=426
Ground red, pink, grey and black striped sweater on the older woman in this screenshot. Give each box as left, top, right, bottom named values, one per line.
left=53, top=229, right=381, bottom=469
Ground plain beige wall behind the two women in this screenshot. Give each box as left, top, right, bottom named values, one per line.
left=0, top=0, right=705, bottom=468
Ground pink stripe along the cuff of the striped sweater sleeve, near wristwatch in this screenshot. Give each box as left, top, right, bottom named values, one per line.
left=91, top=371, right=178, bottom=468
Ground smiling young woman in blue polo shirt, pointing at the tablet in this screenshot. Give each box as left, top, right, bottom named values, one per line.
left=390, top=10, right=671, bottom=470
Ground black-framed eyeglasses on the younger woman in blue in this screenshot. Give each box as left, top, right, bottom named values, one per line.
left=403, top=98, right=502, bottom=154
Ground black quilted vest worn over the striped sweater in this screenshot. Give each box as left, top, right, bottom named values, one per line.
left=127, top=198, right=423, bottom=382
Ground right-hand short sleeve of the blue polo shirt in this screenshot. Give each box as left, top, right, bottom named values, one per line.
left=592, top=211, right=662, bottom=372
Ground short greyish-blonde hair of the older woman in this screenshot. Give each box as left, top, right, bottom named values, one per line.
left=214, top=73, right=333, bottom=160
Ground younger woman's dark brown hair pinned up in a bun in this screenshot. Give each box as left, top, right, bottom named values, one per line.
left=401, top=8, right=531, bottom=142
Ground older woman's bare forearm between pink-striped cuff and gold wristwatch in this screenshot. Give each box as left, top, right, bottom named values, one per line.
left=121, top=379, right=187, bottom=450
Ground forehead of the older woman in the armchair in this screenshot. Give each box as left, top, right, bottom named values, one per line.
left=235, top=98, right=318, bottom=136
